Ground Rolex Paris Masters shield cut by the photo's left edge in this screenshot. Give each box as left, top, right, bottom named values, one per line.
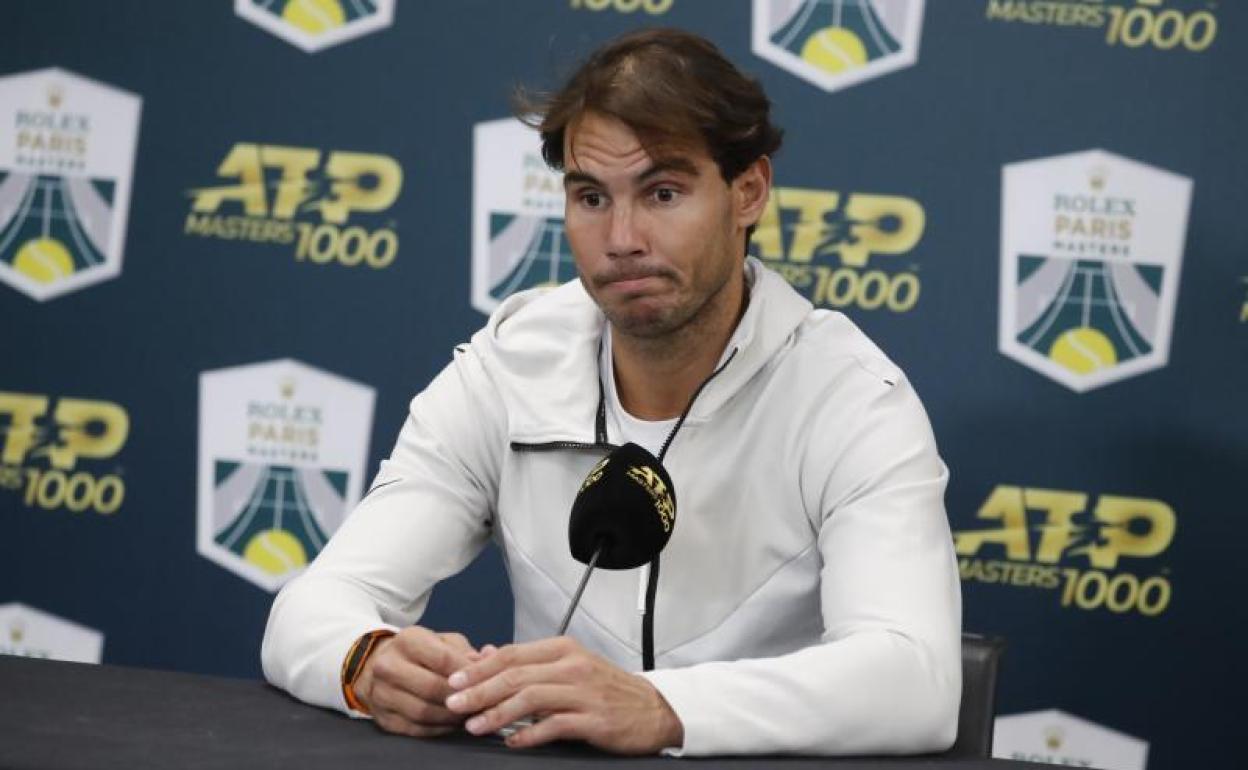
left=0, top=67, right=141, bottom=301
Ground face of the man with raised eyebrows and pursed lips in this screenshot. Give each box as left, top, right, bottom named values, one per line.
left=564, top=112, right=765, bottom=338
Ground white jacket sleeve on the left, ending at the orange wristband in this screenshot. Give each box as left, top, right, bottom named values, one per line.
left=261, top=347, right=505, bottom=715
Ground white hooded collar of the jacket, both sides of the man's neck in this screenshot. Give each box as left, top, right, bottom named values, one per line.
left=473, top=257, right=811, bottom=444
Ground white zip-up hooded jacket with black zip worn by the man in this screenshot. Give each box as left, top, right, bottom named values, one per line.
left=262, top=258, right=961, bottom=755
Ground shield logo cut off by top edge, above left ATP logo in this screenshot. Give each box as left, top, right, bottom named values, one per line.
left=235, top=0, right=394, bottom=54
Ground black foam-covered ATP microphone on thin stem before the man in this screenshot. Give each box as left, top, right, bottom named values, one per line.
left=559, top=443, right=676, bottom=635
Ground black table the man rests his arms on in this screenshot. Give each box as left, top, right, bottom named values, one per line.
left=0, top=655, right=1047, bottom=770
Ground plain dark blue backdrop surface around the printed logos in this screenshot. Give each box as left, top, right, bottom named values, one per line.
left=0, top=0, right=1248, bottom=768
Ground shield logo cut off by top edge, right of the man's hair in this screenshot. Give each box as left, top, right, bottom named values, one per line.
left=753, top=0, right=924, bottom=91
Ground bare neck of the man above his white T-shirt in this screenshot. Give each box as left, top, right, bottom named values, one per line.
left=610, top=276, right=750, bottom=421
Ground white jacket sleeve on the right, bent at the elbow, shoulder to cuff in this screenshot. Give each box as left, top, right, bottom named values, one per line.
left=644, top=369, right=961, bottom=756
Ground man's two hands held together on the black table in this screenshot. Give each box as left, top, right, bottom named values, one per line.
left=356, top=626, right=684, bottom=754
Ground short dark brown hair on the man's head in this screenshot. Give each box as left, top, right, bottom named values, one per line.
left=515, top=29, right=782, bottom=182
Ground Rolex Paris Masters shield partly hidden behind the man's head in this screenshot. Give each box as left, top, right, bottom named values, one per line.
left=472, top=119, right=577, bottom=313
